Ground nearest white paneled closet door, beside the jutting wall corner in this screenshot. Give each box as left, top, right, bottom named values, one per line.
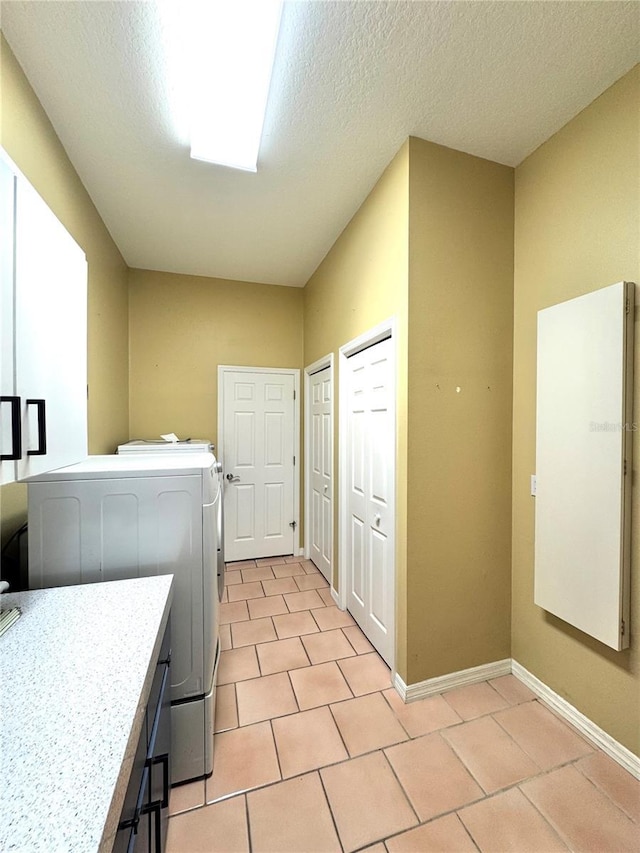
left=341, top=338, right=395, bottom=666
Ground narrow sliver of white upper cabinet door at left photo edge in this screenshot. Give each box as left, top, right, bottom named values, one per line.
left=0, top=158, right=19, bottom=483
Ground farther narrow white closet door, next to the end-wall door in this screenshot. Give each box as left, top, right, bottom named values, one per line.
left=307, top=367, right=333, bottom=583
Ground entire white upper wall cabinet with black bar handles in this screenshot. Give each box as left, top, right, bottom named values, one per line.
left=0, top=150, right=87, bottom=483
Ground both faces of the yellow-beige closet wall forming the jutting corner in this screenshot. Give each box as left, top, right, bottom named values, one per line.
left=304, top=139, right=513, bottom=683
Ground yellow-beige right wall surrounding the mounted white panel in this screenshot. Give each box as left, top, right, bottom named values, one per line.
left=512, top=66, right=640, bottom=753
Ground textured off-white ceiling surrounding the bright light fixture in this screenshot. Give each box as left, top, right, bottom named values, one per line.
left=0, top=0, right=640, bottom=286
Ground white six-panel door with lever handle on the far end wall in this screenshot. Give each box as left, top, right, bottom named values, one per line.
left=219, top=368, right=297, bottom=562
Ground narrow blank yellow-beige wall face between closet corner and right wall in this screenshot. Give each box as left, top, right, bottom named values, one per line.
left=407, top=139, right=513, bottom=683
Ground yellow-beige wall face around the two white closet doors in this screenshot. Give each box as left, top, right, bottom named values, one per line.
left=304, top=143, right=409, bottom=672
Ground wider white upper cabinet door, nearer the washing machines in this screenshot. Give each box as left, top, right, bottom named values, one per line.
left=15, top=175, right=87, bottom=479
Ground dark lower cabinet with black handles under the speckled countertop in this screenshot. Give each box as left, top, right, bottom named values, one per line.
left=113, top=625, right=171, bottom=853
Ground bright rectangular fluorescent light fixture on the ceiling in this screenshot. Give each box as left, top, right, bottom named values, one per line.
left=161, top=0, right=282, bottom=172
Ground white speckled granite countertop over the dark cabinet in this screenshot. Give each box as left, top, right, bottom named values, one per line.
left=0, top=575, right=173, bottom=853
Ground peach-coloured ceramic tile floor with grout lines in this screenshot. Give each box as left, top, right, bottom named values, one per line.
left=167, top=557, right=640, bottom=853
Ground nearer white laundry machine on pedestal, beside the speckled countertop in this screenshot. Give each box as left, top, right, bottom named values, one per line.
left=27, top=453, right=224, bottom=784
